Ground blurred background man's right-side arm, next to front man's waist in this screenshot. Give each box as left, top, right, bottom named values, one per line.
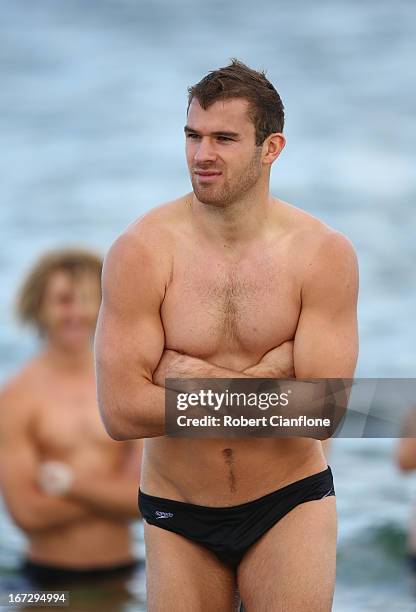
left=67, top=440, right=143, bottom=519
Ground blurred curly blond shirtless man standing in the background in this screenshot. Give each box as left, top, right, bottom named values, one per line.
left=0, top=250, right=141, bottom=584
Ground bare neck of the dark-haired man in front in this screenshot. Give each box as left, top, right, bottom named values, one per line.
left=191, top=183, right=272, bottom=247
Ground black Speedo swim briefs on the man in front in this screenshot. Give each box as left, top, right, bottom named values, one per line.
left=139, top=466, right=335, bottom=568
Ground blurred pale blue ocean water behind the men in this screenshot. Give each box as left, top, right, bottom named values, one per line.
left=0, top=0, right=416, bottom=612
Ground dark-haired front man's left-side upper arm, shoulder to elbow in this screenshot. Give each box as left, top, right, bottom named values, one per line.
left=95, top=231, right=165, bottom=440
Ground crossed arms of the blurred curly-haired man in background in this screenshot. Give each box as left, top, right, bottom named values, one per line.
left=0, top=383, right=141, bottom=534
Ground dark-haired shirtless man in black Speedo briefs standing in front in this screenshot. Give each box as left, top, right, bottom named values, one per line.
left=96, top=60, right=358, bottom=612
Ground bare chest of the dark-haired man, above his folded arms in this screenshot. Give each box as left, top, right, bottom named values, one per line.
left=161, top=244, right=300, bottom=358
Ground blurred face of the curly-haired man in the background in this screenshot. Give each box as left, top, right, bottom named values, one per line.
left=40, top=270, right=100, bottom=351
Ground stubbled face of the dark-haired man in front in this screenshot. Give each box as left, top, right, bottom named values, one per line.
left=185, top=98, right=262, bottom=207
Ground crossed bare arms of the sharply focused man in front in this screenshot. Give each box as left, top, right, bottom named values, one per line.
left=95, top=227, right=358, bottom=440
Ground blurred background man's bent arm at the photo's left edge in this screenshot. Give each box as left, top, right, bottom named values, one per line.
left=0, top=382, right=91, bottom=534
